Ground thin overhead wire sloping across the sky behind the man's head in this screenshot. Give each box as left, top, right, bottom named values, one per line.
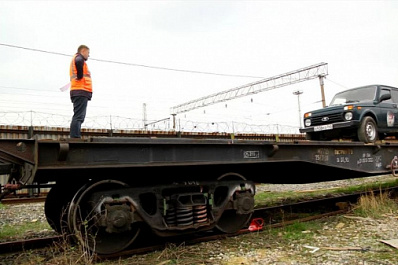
left=0, top=43, right=264, bottom=78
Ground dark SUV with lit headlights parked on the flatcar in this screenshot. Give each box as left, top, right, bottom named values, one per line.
left=300, top=85, right=398, bottom=143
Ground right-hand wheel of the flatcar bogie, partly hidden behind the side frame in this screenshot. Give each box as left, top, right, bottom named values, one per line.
left=216, top=173, right=252, bottom=234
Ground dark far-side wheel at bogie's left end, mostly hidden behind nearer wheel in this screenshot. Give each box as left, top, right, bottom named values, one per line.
left=44, top=184, right=79, bottom=234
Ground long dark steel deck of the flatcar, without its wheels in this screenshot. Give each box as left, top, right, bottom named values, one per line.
left=0, top=137, right=398, bottom=184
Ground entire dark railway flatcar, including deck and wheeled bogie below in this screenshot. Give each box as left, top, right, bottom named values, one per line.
left=0, top=137, right=398, bottom=254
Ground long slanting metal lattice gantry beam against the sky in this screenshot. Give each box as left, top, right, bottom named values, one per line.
left=171, top=63, right=328, bottom=117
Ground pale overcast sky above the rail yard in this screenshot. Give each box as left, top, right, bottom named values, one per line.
left=0, top=1, right=398, bottom=131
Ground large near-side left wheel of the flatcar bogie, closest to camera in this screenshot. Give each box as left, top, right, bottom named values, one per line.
left=68, top=180, right=140, bottom=254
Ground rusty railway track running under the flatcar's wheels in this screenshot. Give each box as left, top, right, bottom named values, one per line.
left=0, top=184, right=398, bottom=260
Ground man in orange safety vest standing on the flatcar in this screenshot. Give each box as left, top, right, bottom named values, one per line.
left=69, top=45, right=93, bottom=138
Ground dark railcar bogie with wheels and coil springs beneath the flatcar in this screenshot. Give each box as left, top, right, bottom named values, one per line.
left=50, top=173, right=255, bottom=254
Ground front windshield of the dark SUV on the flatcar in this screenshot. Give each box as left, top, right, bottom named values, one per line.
left=330, top=86, right=376, bottom=106
